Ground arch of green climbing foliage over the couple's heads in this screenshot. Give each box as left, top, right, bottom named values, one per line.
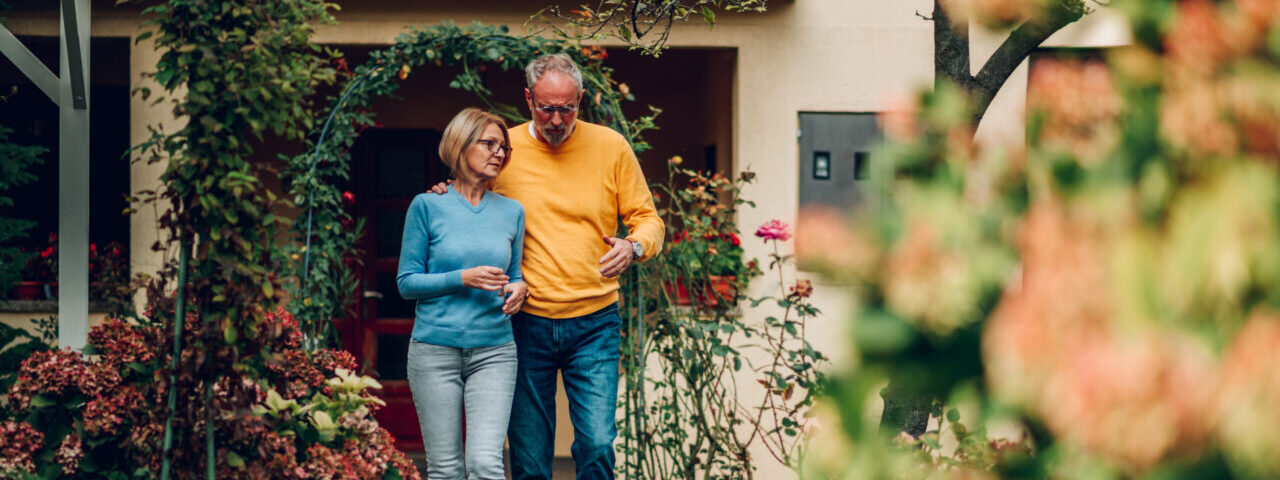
left=283, top=22, right=658, bottom=346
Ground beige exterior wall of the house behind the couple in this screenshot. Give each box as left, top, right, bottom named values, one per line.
left=9, top=0, right=1128, bottom=479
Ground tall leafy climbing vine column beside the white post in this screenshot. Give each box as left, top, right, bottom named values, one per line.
left=120, top=0, right=337, bottom=471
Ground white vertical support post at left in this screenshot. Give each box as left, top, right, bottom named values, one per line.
left=58, top=0, right=90, bottom=349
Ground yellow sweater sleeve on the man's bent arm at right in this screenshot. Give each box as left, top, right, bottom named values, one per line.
left=617, top=148, right=667, bottom=261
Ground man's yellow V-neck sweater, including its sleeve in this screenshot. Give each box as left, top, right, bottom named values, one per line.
left=493, top=120, right=664, bottom=319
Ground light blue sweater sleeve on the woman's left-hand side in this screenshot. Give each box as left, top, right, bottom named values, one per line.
left=396, top=195, right=463, bottom=300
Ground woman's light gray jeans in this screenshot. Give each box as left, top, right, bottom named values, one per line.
left=408, top=339, right=516, bottom=480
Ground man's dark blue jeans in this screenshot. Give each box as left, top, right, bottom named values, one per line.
left=507, top=303, right=622, bottom=480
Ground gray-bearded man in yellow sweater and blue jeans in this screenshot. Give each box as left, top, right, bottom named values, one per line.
left=436, top=54, right=664, bottom=480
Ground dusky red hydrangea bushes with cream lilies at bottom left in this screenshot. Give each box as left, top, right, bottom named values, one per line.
left=0, top=310, right=419, bottom=479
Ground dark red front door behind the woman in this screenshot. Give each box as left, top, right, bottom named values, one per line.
left=346, top=129, right=448, bottom=449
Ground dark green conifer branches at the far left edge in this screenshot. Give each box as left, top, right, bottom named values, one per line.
left=0, top=125, right=46, bottom=297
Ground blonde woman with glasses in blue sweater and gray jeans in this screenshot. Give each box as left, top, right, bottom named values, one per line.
left=397, top=109, right=529, bottom=480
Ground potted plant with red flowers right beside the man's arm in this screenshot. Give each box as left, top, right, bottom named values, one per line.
left=654, top=156, right=759, bottom=308
